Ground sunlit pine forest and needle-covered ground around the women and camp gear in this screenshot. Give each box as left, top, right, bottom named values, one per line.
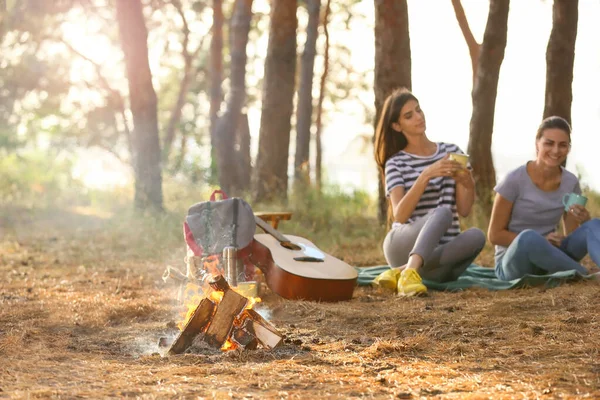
left=0, top=0, right=600, bottom=398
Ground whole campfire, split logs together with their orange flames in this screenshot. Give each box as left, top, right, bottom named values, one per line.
left=167, top=253, right=282, bottom=355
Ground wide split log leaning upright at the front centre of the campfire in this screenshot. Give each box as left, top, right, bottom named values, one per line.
left=204, top=290, right=248, bottom=348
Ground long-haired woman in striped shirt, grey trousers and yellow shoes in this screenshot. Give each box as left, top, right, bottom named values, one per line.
left=375, top=89, right=485, bottom=296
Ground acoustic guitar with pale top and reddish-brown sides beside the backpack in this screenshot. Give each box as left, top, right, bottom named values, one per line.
left=250, top=216, right=358, bottom=302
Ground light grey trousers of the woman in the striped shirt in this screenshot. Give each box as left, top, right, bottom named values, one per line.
left=383, top=207, right=485, bottom=282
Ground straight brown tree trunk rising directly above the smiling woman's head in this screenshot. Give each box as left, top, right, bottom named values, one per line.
left=544, top=0, right=579, bottom=123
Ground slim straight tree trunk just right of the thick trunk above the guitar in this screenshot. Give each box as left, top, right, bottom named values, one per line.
left=294, top=0, right=321, bottom=184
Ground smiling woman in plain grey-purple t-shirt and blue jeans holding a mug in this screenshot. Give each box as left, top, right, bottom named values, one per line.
left=488, top=117, right=600, bottom=280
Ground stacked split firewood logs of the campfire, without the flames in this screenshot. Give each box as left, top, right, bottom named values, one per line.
left=167, top=275, right=282, bottom=355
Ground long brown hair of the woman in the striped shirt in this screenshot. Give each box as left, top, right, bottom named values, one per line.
left=374, top=88, right=419, bottom=225
